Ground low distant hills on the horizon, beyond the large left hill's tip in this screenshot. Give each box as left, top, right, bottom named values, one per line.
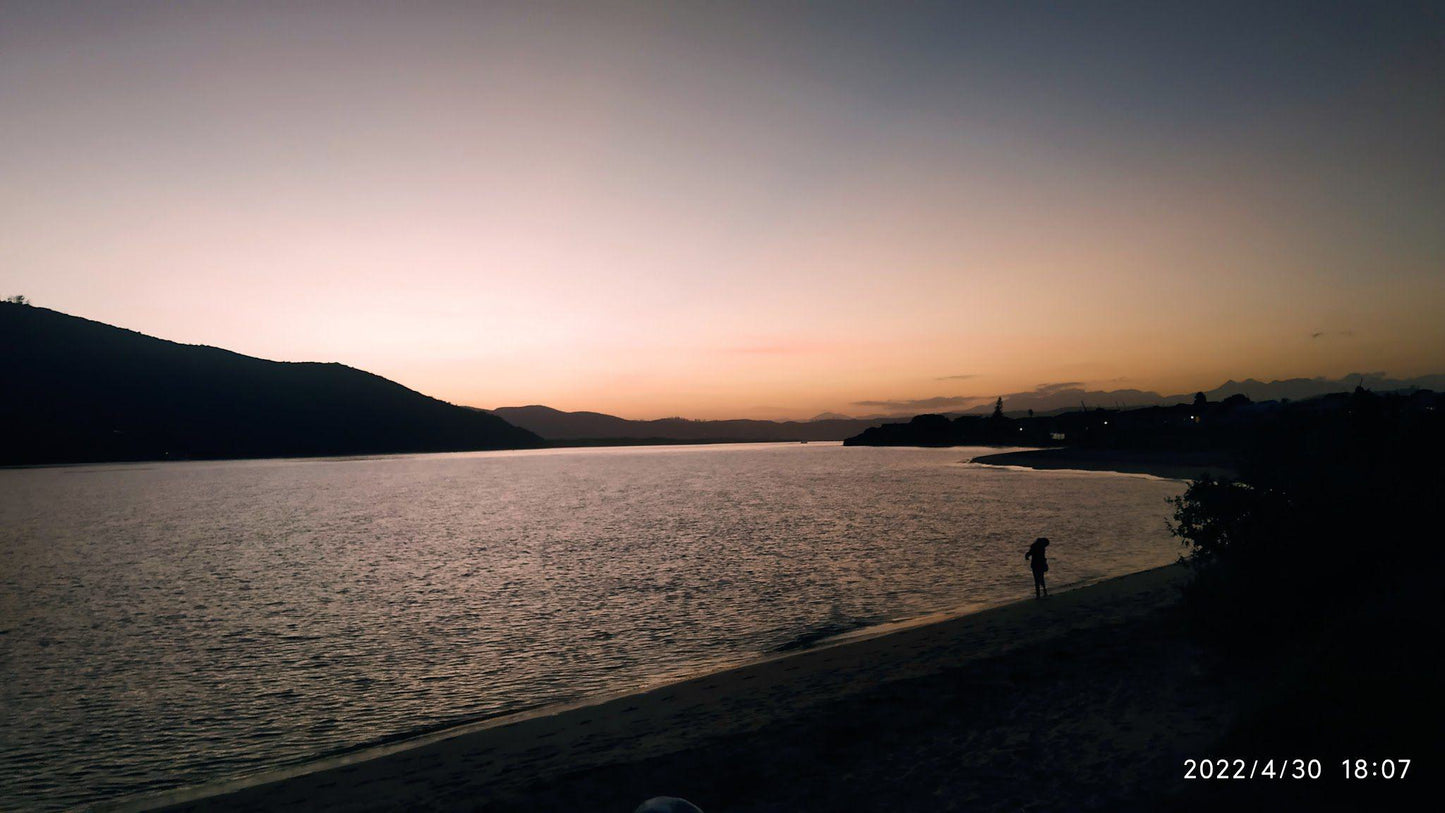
left=491, top=406, right=881, bottom=440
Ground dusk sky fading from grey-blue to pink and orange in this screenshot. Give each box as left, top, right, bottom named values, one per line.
left=0, top=0, right=1445, bottom=419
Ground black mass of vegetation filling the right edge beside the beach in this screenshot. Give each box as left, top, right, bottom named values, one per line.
left=1173, top=388, right=1445, bottom=809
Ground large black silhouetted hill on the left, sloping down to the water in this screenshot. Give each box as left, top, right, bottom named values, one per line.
left=0, top=303, right=542, bottom=465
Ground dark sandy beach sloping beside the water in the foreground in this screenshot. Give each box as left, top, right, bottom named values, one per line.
left=126, top=566, right=1233, bottom=813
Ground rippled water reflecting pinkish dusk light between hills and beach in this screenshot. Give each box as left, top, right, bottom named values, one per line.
left=0, top=443, right=1182, bottom=809
